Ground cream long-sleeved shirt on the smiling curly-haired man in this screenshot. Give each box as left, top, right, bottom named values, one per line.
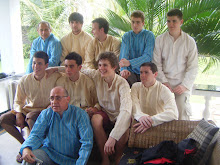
left=82, top=69, right=132, bottom=140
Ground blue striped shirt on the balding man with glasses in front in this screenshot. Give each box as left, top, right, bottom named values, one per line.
left=20, top=105, right=93, bottom=165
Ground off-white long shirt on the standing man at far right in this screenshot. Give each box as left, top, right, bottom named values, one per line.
left=153, top=31, right=198, bottom=93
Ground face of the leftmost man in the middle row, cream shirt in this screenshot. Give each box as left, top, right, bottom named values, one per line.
left=32, top=57, right=48, bottom=77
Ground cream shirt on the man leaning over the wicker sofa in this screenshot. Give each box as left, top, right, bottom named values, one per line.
left=131, top=81, right=178, bottom=126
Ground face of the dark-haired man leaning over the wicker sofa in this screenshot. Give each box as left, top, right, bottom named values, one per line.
left=140, top=66, right=158, bottom=86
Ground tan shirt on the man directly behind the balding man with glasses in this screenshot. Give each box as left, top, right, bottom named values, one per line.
left=56, top=73, right=98, bottom=109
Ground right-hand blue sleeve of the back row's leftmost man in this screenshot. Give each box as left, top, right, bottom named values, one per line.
left=49, top=40, right=62, bottom=67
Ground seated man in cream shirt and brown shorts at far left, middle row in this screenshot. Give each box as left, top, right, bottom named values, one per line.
left=0, top=51, right=60, bottom=162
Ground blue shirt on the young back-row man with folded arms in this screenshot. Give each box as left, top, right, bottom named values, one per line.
left=119, top=29, right=155, bottom=74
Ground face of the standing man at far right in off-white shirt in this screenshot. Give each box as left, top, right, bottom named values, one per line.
left=167, top=16, right=183, bottom=33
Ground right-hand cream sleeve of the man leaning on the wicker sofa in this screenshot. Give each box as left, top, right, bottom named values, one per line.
left=151, top=86, right=178, bottom=126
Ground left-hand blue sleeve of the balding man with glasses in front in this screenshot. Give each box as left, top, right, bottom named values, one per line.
left=20, top=109, right=50, bottom=154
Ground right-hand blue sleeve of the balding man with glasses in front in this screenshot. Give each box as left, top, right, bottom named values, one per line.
left=76, top=112, right=93, bottom=165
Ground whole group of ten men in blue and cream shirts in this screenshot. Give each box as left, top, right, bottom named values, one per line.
left=0, top=9, right=198, bottom=165
